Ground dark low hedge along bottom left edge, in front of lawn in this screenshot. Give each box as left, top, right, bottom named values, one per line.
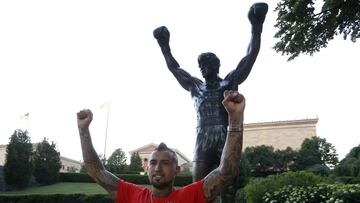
left=0, top=194, right=114, bottom=203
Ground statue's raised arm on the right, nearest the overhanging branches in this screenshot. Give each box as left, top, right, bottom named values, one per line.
left=225, top=3, right=268, bottom=90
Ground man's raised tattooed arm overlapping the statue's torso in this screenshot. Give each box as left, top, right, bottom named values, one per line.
left=203, top=90, right=245, bottom=201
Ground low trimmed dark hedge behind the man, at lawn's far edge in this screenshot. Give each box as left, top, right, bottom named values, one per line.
left=60, top=173, right=192, bottom=186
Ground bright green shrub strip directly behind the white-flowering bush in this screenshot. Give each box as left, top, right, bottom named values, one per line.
left=244, top=171, right=323, bottom=203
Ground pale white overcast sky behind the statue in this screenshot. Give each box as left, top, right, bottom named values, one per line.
left=0, top=0, right=360, bottom=160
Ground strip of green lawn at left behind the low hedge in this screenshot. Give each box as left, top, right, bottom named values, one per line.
left=0, top=182, right=107, bottom=195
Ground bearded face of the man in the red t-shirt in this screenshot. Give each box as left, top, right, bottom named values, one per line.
left=149, top=151, right=180, bottom=189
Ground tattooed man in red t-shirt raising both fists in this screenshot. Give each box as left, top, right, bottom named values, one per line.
left=77, top=90, right=245, bottom=203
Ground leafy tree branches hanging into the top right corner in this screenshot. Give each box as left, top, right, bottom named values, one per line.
left=274, top=0, right=360, bottom=60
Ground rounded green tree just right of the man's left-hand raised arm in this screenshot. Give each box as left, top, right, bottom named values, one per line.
left=106, top=148, right=127, bottom=174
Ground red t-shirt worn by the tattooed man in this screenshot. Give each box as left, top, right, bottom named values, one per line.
left=116, top=180, right=207, bottom=203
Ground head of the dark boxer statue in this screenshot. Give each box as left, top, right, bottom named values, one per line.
left=198, top=52, right=220, bottom=79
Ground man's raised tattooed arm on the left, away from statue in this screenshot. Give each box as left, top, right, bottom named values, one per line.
left=77, top=110, right=119, bottom=199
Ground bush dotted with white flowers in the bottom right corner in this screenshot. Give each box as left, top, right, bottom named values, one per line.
left=263, top=184, right=360, bottom=203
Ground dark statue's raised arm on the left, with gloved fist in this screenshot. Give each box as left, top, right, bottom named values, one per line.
left=153, top=26, right=197, bottom=91
